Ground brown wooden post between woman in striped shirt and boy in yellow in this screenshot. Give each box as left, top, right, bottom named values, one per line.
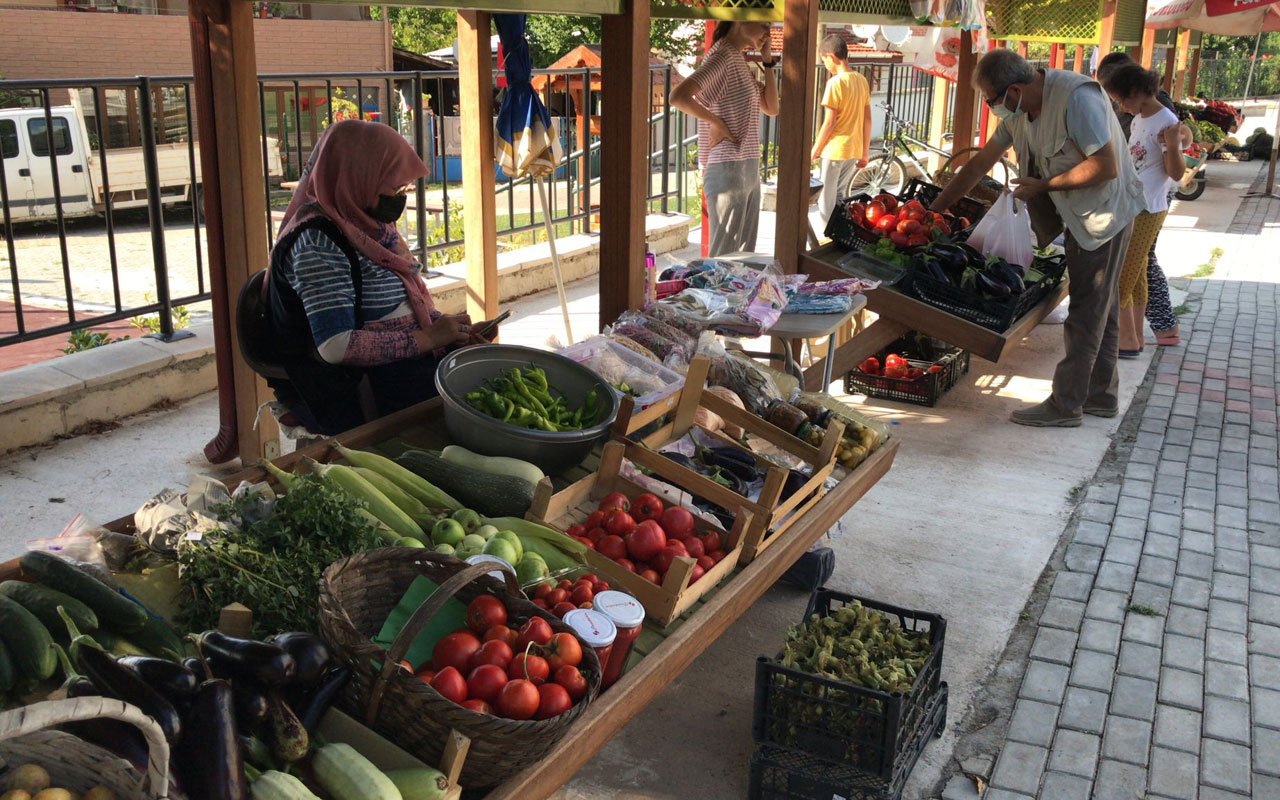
left=773, top=0, right=818, bottom=273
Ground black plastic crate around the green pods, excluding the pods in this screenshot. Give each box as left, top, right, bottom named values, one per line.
left=751, top=589, right=947, bottom=782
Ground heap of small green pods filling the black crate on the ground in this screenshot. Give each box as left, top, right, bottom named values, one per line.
left=781, top=600, right=929, bottom=692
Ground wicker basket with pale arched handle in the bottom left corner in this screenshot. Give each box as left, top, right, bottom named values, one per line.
left=0, top=698, right=184, bottom=800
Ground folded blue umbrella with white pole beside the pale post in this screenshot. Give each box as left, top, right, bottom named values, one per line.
left=493, top=14, right=573, bottom=344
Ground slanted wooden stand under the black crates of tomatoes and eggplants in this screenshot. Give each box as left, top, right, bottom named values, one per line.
left=800, top=243, right=1069, bottom=390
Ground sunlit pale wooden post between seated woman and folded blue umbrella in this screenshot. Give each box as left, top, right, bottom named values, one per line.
left=458, top=12, right=498, bottom=320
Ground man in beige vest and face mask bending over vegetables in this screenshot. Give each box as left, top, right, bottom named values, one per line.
left=933, top=49, right=1146, bottom=428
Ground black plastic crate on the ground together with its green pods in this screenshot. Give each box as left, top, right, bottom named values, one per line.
left=751, top=589, right=946, bottom=797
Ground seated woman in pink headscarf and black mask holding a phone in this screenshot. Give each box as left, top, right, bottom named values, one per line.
left=269, top=120, right=494, bottom=434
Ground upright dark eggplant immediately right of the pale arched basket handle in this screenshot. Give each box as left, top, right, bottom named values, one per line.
left=173, top=678, right=248, bottom=800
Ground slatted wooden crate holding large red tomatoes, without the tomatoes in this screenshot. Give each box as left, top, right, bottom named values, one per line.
left=527, top=442, right=750, bottom=625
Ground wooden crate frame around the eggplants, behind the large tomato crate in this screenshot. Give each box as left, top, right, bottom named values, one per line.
left=613, top=357, right=845, bottom=564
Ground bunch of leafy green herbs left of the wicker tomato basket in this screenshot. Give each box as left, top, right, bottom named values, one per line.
left=177, top=475, right=381, bottom=636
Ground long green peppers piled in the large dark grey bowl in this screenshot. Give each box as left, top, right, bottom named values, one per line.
left=466, top=366, right=602, bottom=431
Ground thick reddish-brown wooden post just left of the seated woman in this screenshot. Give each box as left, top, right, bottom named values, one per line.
left=188, top=0, right=280, bottom=466
